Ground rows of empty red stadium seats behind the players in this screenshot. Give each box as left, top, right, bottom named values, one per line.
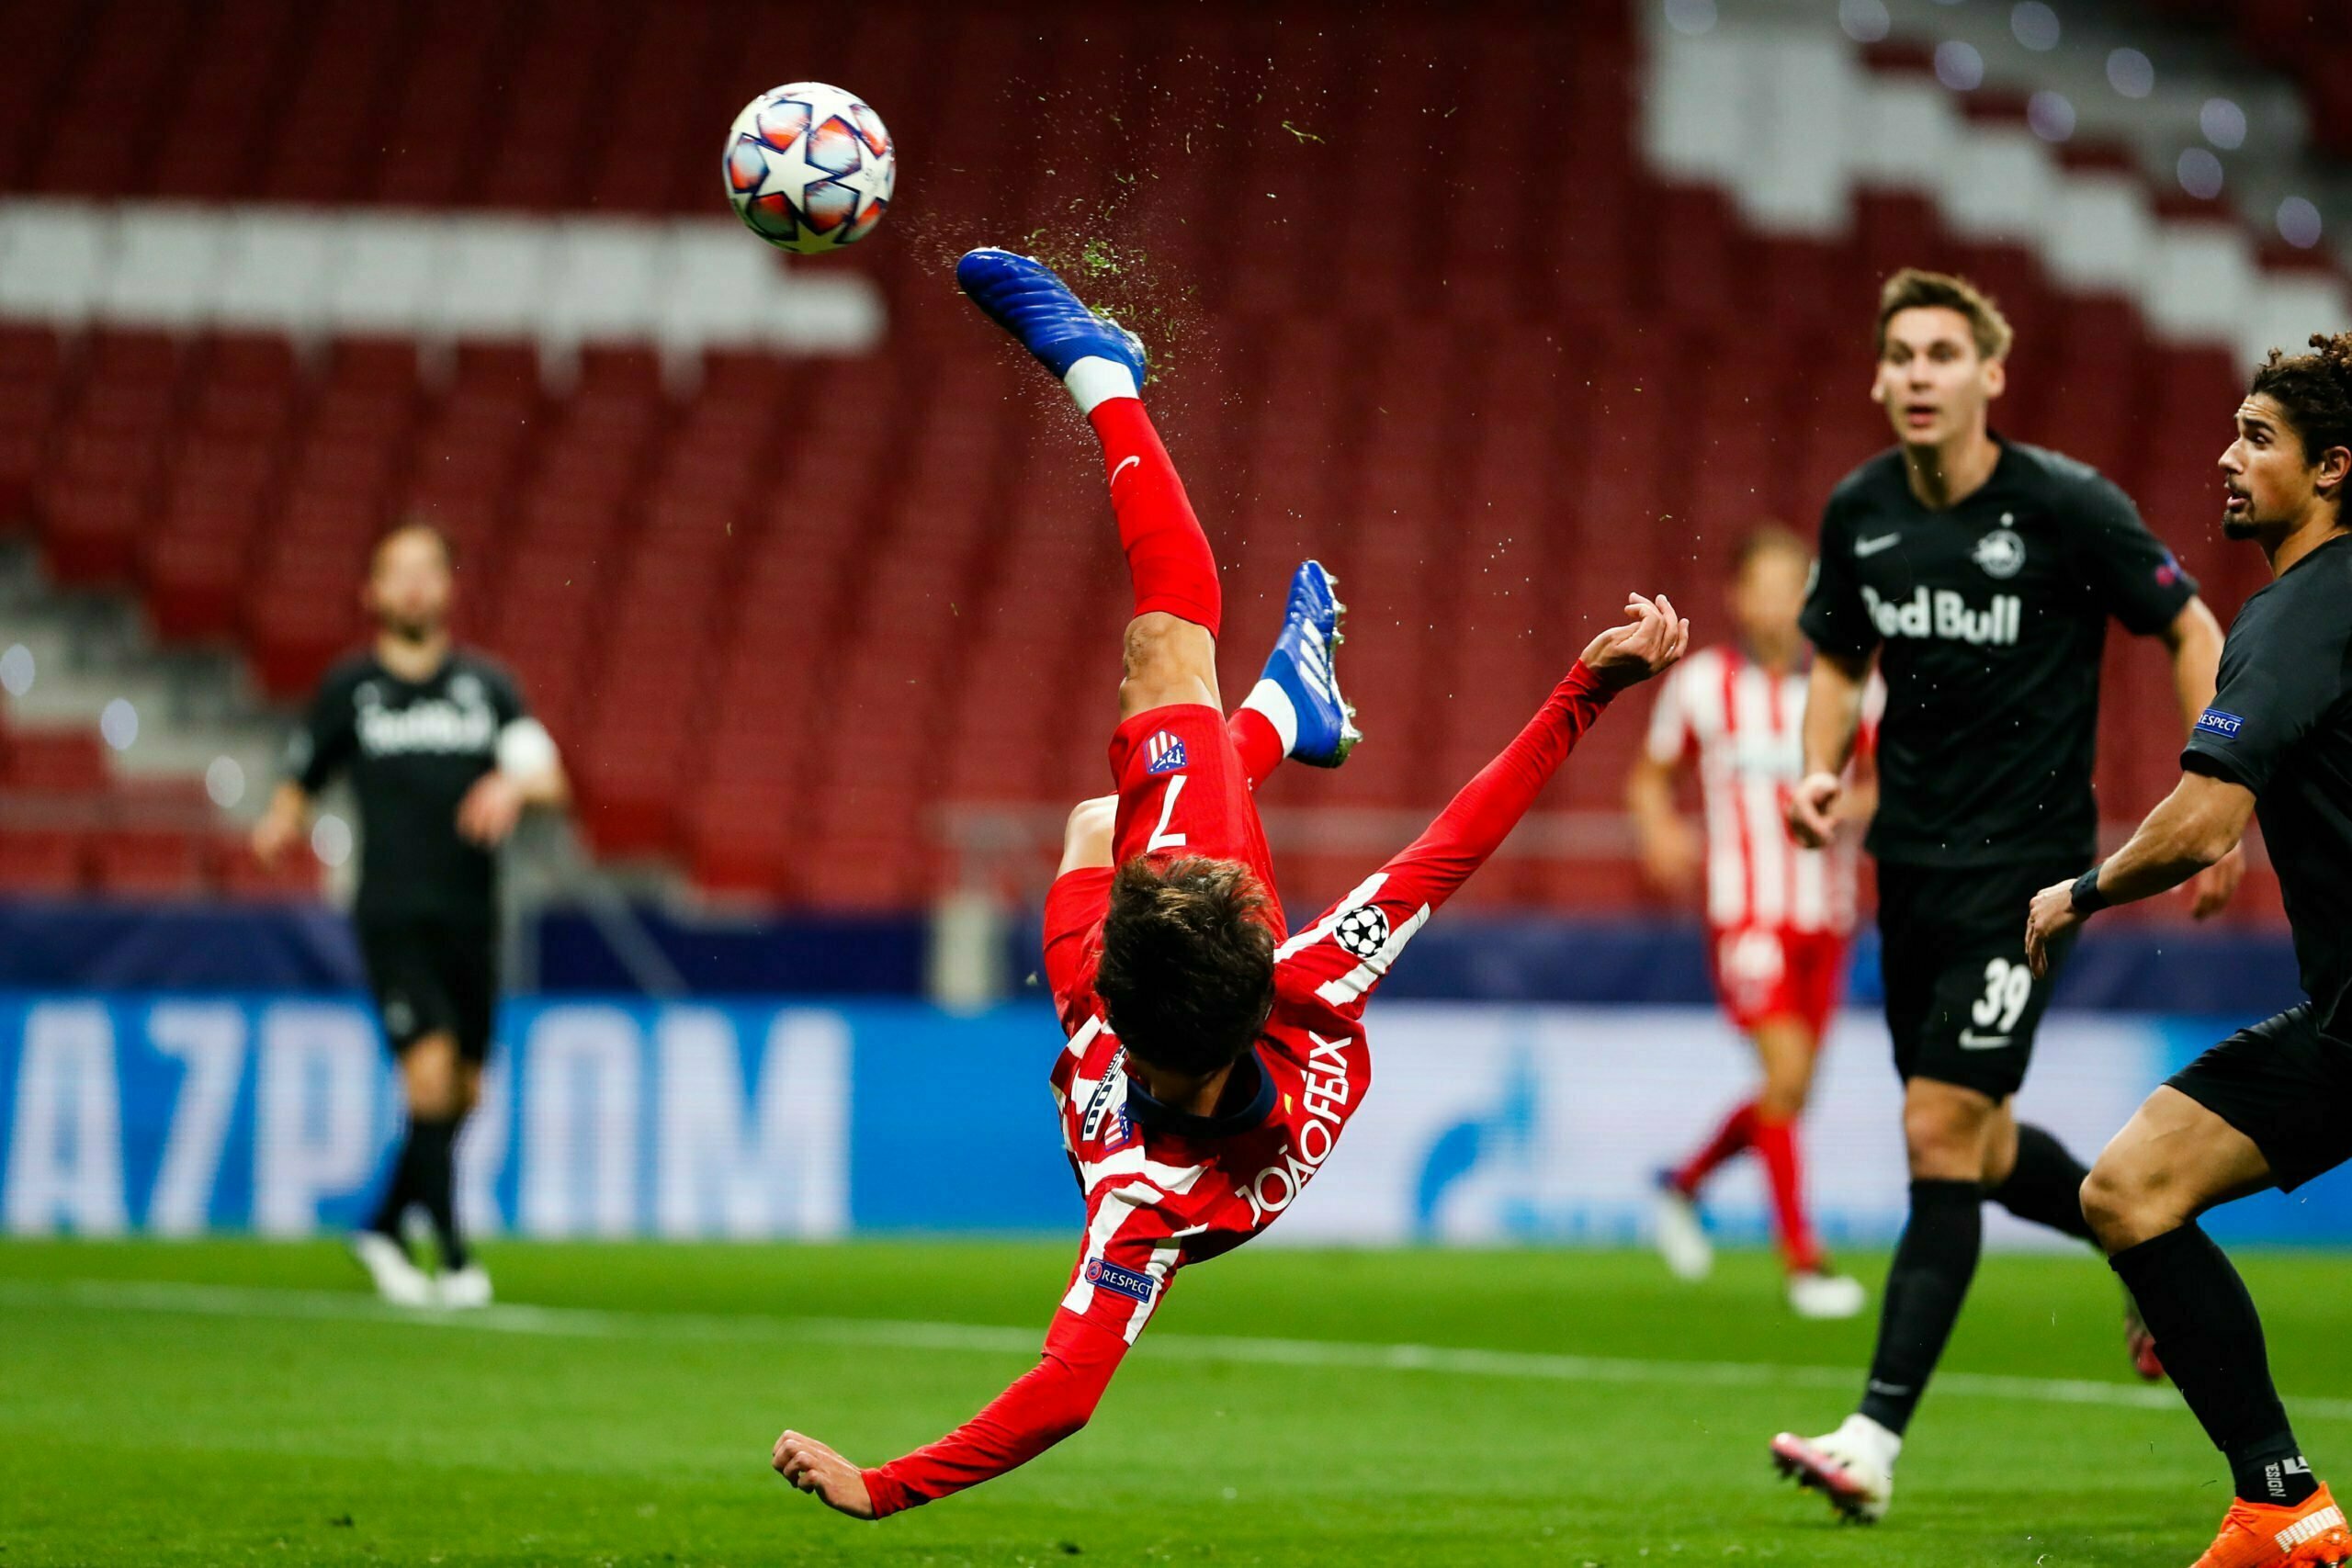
left=0, top=0, right=2314, bottom=912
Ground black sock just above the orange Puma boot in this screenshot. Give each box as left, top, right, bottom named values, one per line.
left=2108, top=1220, right=2319, bottom=1505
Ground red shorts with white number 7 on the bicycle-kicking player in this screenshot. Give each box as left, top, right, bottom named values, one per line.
left=1045, top=703, right=1286, bottom=1027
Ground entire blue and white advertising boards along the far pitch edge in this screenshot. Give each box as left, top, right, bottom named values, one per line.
left=0, top=992, right=2352, bottom=1246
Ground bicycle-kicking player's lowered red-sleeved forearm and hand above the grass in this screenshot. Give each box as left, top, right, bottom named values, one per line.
left=769, top=1309, right=1126, bottom=1518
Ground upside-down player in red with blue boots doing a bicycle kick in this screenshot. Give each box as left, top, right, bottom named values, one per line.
left=772, top=249, right=1689, bottom=1518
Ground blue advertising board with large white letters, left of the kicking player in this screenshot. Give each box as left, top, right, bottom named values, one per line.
left=0, top=995, right=1077, bottom=1239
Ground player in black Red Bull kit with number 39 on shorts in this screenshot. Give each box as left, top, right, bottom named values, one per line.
left=1773, top=270, right=2242, bottom=1518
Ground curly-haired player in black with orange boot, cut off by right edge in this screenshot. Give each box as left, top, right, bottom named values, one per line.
left=2025, top=333, right=2352, bottom=1568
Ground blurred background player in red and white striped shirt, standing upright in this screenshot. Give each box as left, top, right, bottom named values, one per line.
left=1625, top=526, right=1879, bottom=1319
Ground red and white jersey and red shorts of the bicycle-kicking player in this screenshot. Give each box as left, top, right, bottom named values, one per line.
left=864, top=663, right=1611, bottom=1517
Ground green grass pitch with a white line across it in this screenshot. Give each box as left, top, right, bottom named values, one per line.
left=0, top=1241, right=2352, bottom=1568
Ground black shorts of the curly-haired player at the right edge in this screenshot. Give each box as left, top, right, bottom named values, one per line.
left=2166, top=1001, right=2352, bottom=1192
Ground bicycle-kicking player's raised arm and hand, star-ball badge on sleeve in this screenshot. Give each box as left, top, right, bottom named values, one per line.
left=1277, top=594, right=1691, bottom=1010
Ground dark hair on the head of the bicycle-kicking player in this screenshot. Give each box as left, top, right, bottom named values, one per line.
left=1093, top=856, right=1275, bottom=1077
